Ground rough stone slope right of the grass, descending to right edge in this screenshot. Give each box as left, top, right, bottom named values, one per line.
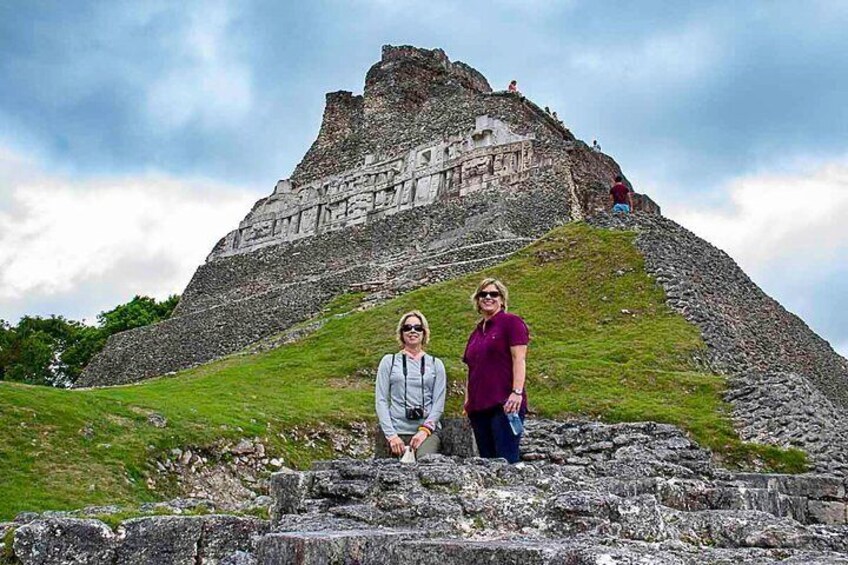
left=590, top=214, right=848, bottom=476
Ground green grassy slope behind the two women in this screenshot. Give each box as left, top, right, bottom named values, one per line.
left=0, top=224, right=805, bottom=520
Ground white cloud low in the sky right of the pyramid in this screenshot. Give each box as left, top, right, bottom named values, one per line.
left=666, top=161, right=848, bottom=270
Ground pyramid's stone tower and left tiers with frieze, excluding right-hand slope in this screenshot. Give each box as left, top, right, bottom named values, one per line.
left=77, top=46, right=659, bottom=386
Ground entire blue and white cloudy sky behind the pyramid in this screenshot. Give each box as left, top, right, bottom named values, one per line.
left=0, top=0, right=848, bottom=354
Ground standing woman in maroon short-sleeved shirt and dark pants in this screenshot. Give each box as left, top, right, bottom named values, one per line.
left=462, top=279, right=530, bottom=463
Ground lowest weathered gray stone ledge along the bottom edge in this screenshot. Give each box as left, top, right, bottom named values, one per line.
left=256, top=530, right=848, bottom=565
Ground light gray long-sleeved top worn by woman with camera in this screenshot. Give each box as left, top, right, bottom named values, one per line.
left=374, top=353, right=447, bottom=438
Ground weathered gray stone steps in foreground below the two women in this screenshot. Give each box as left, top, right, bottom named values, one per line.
left=8, top=420, right=848, bottom=565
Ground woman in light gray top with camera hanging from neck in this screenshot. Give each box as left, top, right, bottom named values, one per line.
left=375, top=310, right=447, bottom=457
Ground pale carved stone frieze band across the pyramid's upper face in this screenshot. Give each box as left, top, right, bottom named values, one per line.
left=212, top=116, right=549, bottom=256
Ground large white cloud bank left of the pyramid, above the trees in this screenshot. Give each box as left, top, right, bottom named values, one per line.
left=0, top=147, right=257, bottom=321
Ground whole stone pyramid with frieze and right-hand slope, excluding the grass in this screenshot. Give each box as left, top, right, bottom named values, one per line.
left=78, top=46, right=848, bottom=477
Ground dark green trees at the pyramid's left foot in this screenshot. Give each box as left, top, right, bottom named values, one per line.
left=0, top=295, right=180, bottom=386
